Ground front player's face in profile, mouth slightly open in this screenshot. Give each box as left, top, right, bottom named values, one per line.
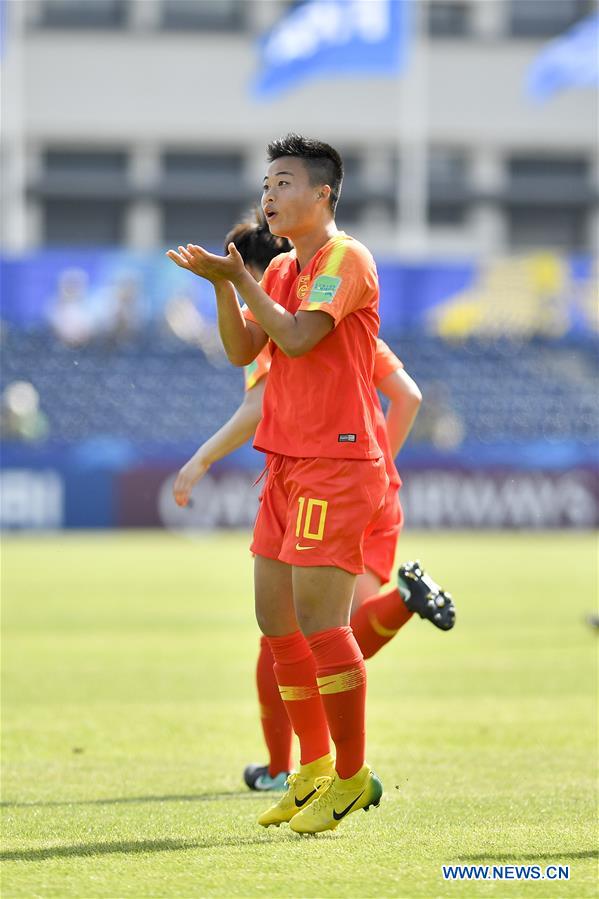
left=262, top=156, right=322, bottom=240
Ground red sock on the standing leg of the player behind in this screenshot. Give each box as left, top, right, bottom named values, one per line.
left=256, top=637, right=293, bottom=777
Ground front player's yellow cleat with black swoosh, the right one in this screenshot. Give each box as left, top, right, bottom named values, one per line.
left=289, top=765, right=383, bottom=833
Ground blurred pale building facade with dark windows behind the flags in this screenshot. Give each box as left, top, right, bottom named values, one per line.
left=1, top=0, right=599, bottom=258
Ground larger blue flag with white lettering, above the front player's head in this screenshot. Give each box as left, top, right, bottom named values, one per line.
left=253, top=0, right=411, bottom=97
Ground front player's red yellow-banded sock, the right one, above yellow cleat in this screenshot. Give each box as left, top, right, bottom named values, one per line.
left=306, top=627, right=366, bottom=780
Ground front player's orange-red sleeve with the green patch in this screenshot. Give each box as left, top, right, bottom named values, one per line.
left=298, top=240, right=378, bottom=325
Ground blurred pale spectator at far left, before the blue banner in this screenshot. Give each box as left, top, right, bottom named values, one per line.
left=48, top=268, right=94, bottom=347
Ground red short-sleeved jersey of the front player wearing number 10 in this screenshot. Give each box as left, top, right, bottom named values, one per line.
left=244, top=232, right=382, bottom=459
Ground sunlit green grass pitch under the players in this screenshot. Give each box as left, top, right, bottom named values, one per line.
left=2, top=532, right=597, bottom=899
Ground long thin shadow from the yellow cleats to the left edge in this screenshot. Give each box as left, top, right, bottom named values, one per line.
left=0, top=833, right=299, bottom=862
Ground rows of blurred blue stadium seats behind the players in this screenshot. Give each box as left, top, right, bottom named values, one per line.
left=2, top=327, right=599, bottom=446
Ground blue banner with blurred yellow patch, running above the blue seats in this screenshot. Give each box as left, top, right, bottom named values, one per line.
left=0, top=249, right=597, bottom=338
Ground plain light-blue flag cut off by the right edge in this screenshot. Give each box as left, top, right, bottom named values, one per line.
left=527, top=13, right=599, bottom=100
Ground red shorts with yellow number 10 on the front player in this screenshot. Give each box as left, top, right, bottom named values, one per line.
left=251, top=454, right=389, bottom=574
